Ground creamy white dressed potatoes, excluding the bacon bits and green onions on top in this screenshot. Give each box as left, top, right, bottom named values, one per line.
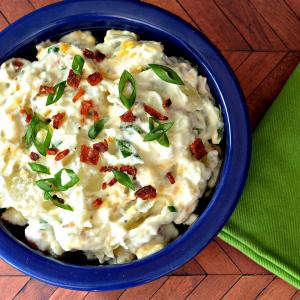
left=0, top=30, right=223, bottom=263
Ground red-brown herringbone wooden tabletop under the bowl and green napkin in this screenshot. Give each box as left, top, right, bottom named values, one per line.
left=0, top=0, right=300, bottom=300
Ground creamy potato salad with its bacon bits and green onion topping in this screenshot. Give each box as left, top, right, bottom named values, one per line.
left=0, top=29, right=223, bottom=264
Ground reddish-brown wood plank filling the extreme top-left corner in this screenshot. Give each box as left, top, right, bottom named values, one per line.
left=0, top=0, right=33, bottom=22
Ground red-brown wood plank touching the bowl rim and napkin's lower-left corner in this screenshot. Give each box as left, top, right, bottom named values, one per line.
left=196, top=241, right=241, bottom=274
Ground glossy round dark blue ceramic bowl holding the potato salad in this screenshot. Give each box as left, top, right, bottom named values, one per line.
left=0, top=0, right=251, bottom=290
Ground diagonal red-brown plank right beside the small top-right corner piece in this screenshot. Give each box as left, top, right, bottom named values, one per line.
left=251, top=0, right=300, bottom=50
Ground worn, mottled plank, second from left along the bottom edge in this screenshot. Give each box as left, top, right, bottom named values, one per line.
left=14, top=279, right=56, bottom=300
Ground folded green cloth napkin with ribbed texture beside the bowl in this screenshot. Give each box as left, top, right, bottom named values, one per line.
left=219, top=64, right=300, bottom=289
